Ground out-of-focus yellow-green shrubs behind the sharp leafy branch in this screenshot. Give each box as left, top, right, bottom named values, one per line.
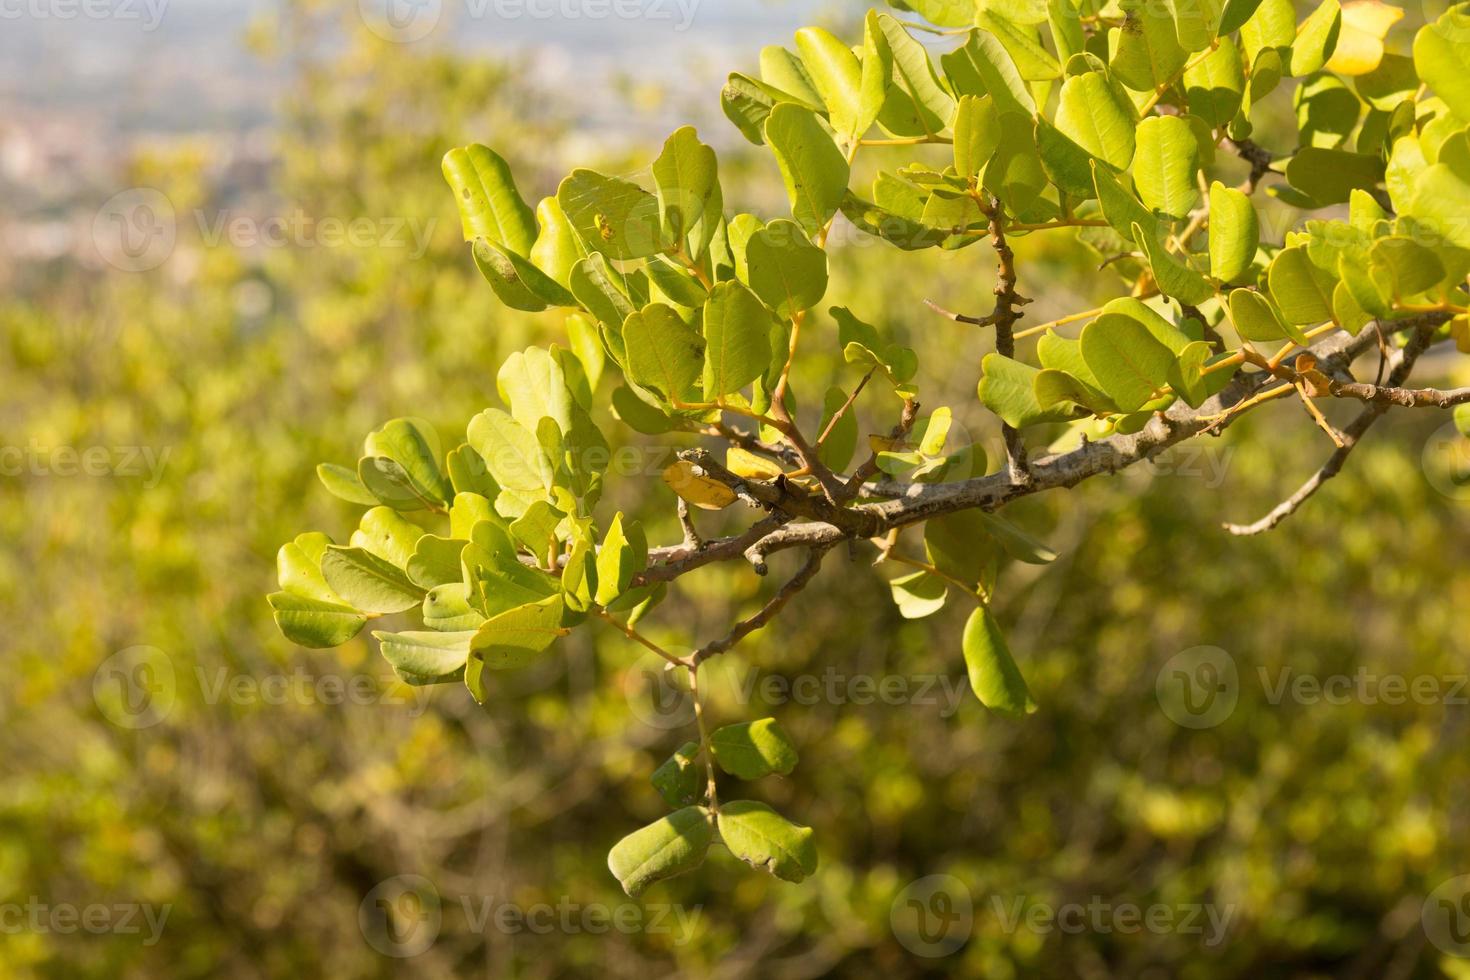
left=0, top=6, right=1470, bottom=979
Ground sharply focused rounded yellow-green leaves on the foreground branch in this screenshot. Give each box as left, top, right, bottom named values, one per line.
left=270, top=0, right=1470, bottom=893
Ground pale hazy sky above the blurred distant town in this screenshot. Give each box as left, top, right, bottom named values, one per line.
left=0, top=0, right=869, bottom=129
